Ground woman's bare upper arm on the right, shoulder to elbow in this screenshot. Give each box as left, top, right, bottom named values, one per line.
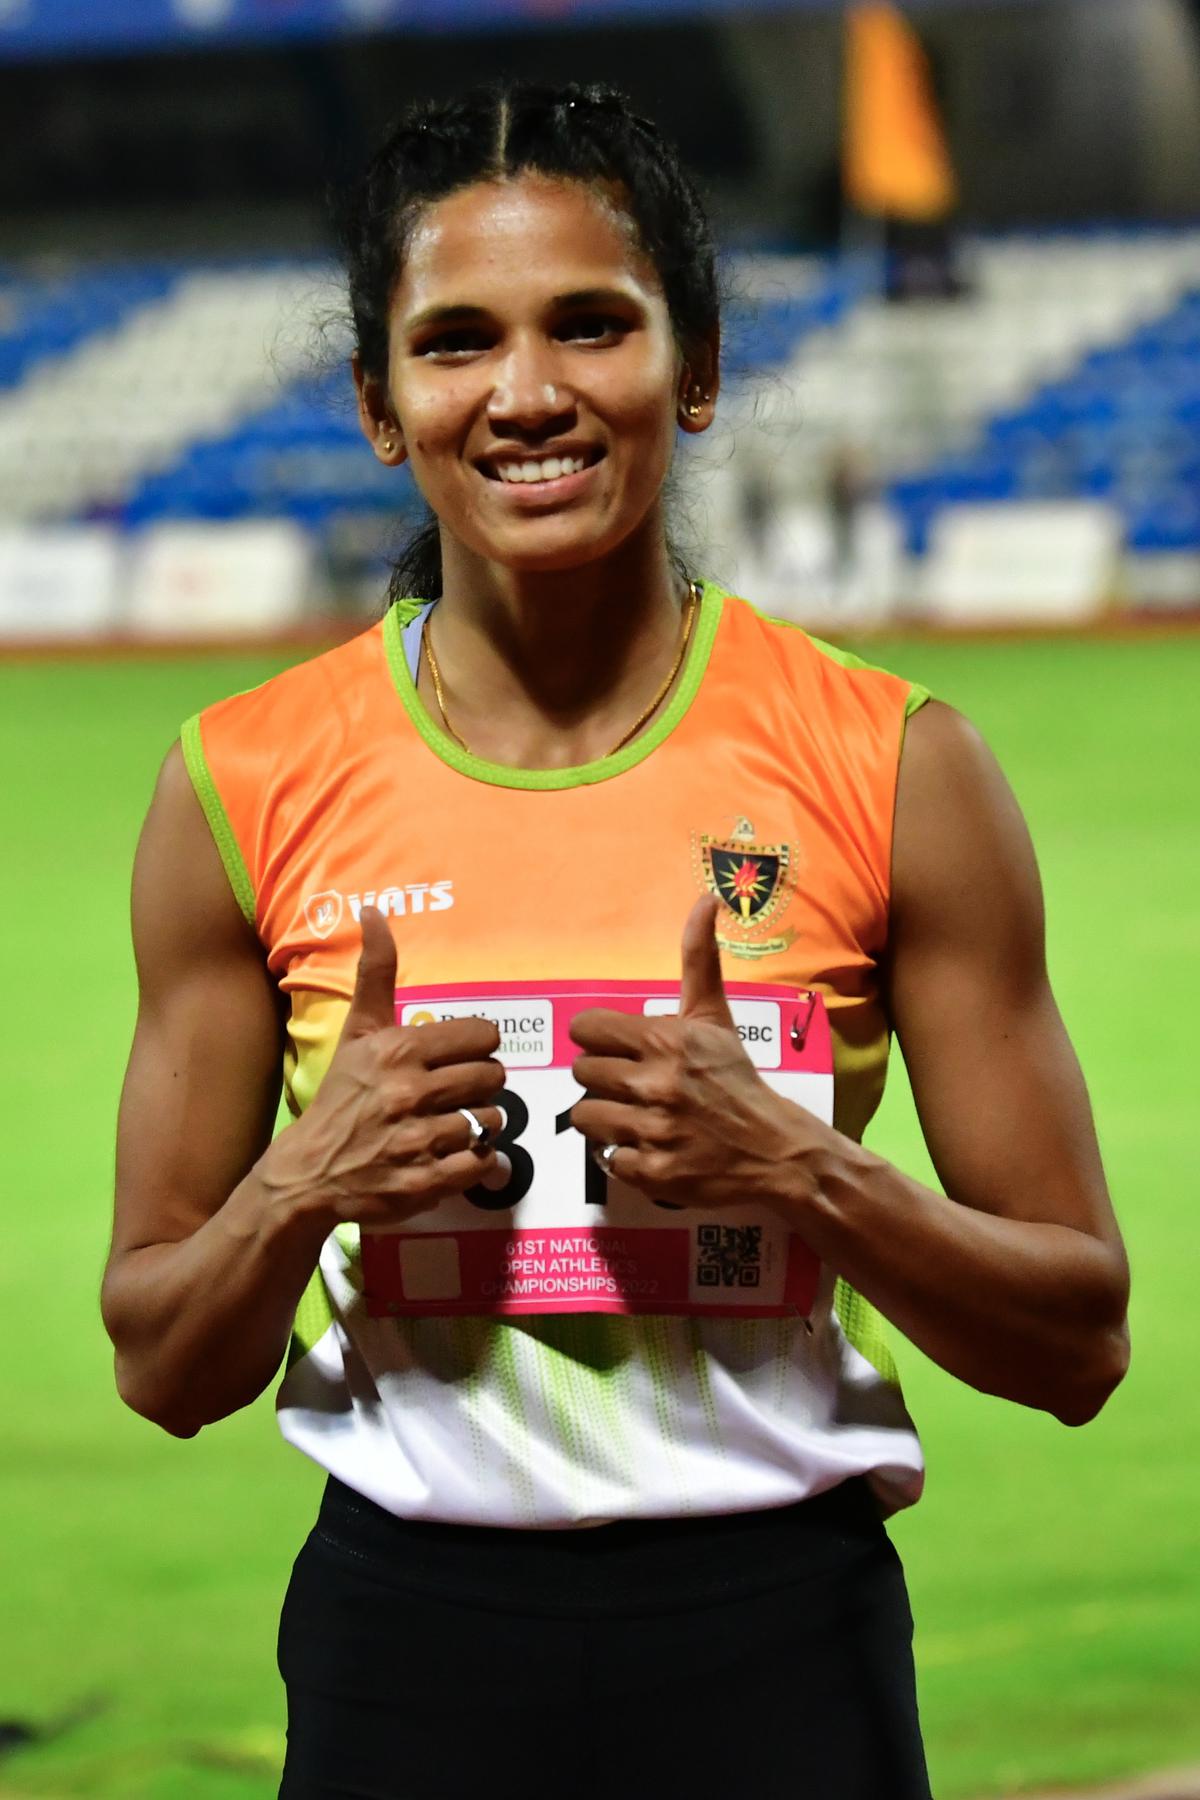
left=887, top=702, right=1119, bottom=1255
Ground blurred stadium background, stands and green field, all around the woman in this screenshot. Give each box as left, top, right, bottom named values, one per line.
left=0, top=0, right=1200, bottom=1800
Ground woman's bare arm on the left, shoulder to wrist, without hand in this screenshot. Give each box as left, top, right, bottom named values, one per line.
left=103, top=749, right=324, bottom=1436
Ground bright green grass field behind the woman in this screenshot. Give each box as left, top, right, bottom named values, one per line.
left=0, top=635, right=1200, bottom=1800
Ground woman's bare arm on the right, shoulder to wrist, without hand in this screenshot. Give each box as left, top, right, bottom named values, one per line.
left=799, top=704, right=1128, bottom=1424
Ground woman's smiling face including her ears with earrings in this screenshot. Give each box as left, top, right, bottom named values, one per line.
left=360, top=175, right=714, bottom=571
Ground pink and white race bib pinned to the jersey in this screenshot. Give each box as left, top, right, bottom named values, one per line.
left=362, top=981, right=833, bottom=1318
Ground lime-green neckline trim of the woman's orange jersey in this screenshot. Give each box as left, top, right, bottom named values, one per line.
left=383, top=581, right=725, bottom=788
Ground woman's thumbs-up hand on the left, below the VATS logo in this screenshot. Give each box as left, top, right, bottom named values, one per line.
left=257, top=905, right=509, bottom=1229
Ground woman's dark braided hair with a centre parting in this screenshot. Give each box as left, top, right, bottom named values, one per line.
left=338, top=83, right=720, bottom=603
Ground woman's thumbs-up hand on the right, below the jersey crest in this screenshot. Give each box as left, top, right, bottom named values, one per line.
left=570, top=895, right=829, bottom=1208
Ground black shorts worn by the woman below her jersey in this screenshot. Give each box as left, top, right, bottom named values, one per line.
left=279, top=1481, right=930, bottom=1800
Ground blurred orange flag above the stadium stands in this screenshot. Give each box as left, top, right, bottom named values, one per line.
left=844, top=0, right=957, bottom=221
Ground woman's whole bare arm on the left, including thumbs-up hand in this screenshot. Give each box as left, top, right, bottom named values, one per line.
left=103, top=749, right=504, bottom=1436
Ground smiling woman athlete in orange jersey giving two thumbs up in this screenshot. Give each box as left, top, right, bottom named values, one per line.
left=104, top=86, right=1128, bottom=1800
